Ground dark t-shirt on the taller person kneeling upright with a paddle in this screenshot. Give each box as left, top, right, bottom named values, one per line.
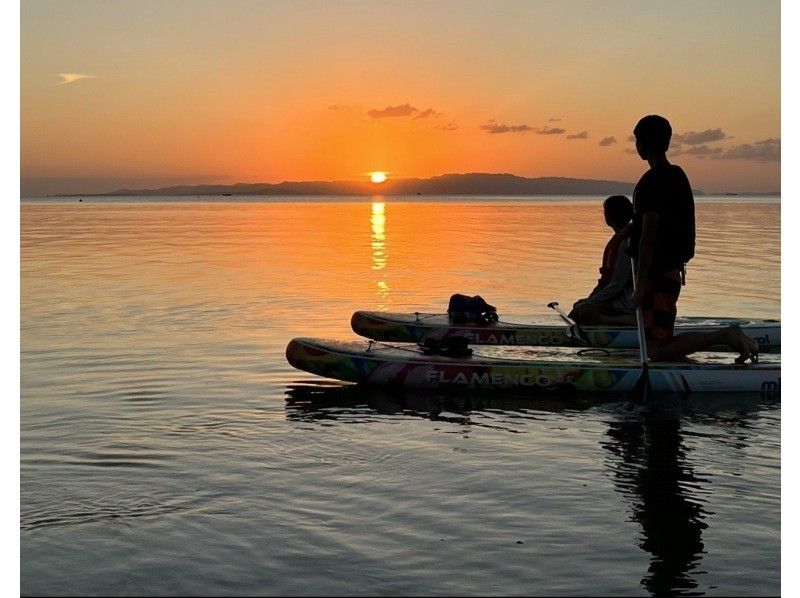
left=630, top=164, right=695, bottom=274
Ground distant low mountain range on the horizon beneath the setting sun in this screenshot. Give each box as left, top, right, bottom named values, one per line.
left=94, top=173, right=703, bottom=196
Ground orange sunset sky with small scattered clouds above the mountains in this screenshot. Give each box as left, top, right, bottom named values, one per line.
left=20, top=0, right=781, bottom=196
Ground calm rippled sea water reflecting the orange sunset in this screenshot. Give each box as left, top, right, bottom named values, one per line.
left=20, top=198, right=781, bottom=596
